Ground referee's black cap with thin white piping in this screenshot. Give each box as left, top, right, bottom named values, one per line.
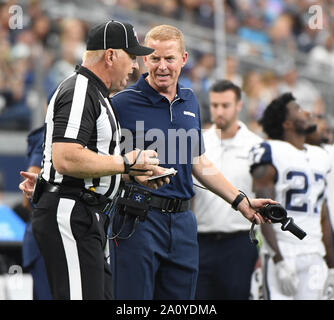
left=87, top=20, right=154, bottom=56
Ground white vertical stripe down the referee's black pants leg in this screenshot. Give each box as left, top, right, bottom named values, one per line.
left=57, top=198, right=82, bottom=300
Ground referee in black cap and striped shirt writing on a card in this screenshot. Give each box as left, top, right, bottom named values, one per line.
left=32, top=21, right=159, bottom=300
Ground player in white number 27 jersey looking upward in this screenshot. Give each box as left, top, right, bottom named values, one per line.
left=250, top=93, right=334, bottom=300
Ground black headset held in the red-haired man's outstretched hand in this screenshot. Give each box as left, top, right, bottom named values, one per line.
left=194, top=183, right=306, bottom=245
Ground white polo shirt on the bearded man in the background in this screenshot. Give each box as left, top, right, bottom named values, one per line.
left=192, top=121, right=262, bottom=233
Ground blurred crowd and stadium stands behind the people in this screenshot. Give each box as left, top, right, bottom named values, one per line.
left=0, top=0, right=334, bottom=240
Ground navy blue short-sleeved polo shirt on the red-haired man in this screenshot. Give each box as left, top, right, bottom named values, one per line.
left=111, top=73, right=204, bottom=199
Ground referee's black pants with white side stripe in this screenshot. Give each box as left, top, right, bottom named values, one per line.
left=32, top=192, right=112, bottom=300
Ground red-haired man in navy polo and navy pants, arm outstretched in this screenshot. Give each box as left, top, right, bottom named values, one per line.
left=110, top=25, right=272, bottom=300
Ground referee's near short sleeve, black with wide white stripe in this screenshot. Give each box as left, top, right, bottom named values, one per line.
left=52, top=89, right=100, bottom=146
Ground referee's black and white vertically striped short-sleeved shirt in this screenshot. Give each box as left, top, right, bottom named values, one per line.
left=42, top=66, right=121, bottom=198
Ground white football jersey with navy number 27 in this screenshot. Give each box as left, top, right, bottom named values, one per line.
left=250, top=140, right=330, bottom=256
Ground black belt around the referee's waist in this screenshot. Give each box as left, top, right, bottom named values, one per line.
left=43, top=181, right=110, bottom=209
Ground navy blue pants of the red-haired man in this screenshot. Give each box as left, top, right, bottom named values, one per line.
left=110, top=210, right=198, bottom=300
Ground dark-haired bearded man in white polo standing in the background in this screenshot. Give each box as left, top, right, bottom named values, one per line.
left=193, top=80, right=262, bottom=300
